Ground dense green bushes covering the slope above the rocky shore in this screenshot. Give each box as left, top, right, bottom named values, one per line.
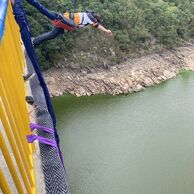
left=25, top=0, right=194, bottom=69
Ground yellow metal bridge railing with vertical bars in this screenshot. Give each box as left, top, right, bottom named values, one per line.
left=0, top=1, right=36, bottom=194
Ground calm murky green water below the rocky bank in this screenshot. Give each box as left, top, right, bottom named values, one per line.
left=53, top=72, right=194, bottom=194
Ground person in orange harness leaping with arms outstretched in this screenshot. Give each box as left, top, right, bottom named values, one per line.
left=32, top=10, right=112, bottom=47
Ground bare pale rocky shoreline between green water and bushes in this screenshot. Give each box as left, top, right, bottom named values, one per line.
left=44, top=44, right=194, bottom=96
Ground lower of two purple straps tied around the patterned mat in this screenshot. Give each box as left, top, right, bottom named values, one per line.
left=26, top=134, right=58, bottom=150
